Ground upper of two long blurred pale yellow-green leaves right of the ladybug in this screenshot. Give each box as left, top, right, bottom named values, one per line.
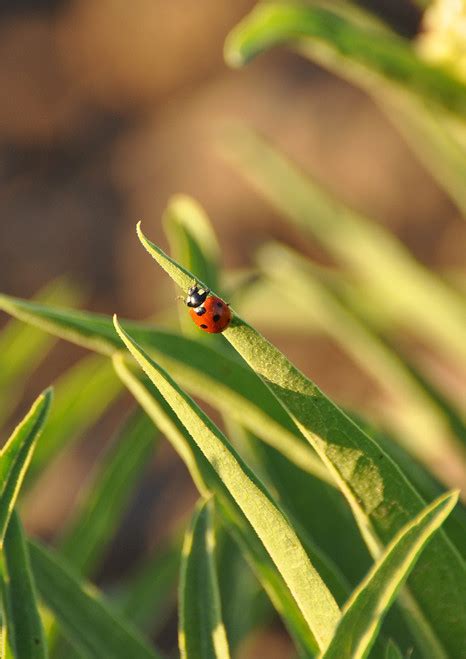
left=220, top=126, right=466, bottom=372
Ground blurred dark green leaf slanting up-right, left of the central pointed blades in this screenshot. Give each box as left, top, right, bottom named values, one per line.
left=59, top=411, right=156, bottom=575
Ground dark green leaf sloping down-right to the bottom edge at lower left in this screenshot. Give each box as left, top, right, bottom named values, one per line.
left=29, top=542, right=160, bottom=659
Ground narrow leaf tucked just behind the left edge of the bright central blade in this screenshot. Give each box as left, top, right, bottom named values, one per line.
left=113, top=355, right=328, bottom=657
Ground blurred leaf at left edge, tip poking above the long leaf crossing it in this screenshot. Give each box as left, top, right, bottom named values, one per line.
left=0, top=279, right=81, bottom=424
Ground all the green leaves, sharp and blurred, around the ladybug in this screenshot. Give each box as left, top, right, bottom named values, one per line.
left=0, top=2, right=466, bottom=659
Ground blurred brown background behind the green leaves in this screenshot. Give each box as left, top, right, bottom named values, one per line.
left=0, top=0, right=466, bottom=656
